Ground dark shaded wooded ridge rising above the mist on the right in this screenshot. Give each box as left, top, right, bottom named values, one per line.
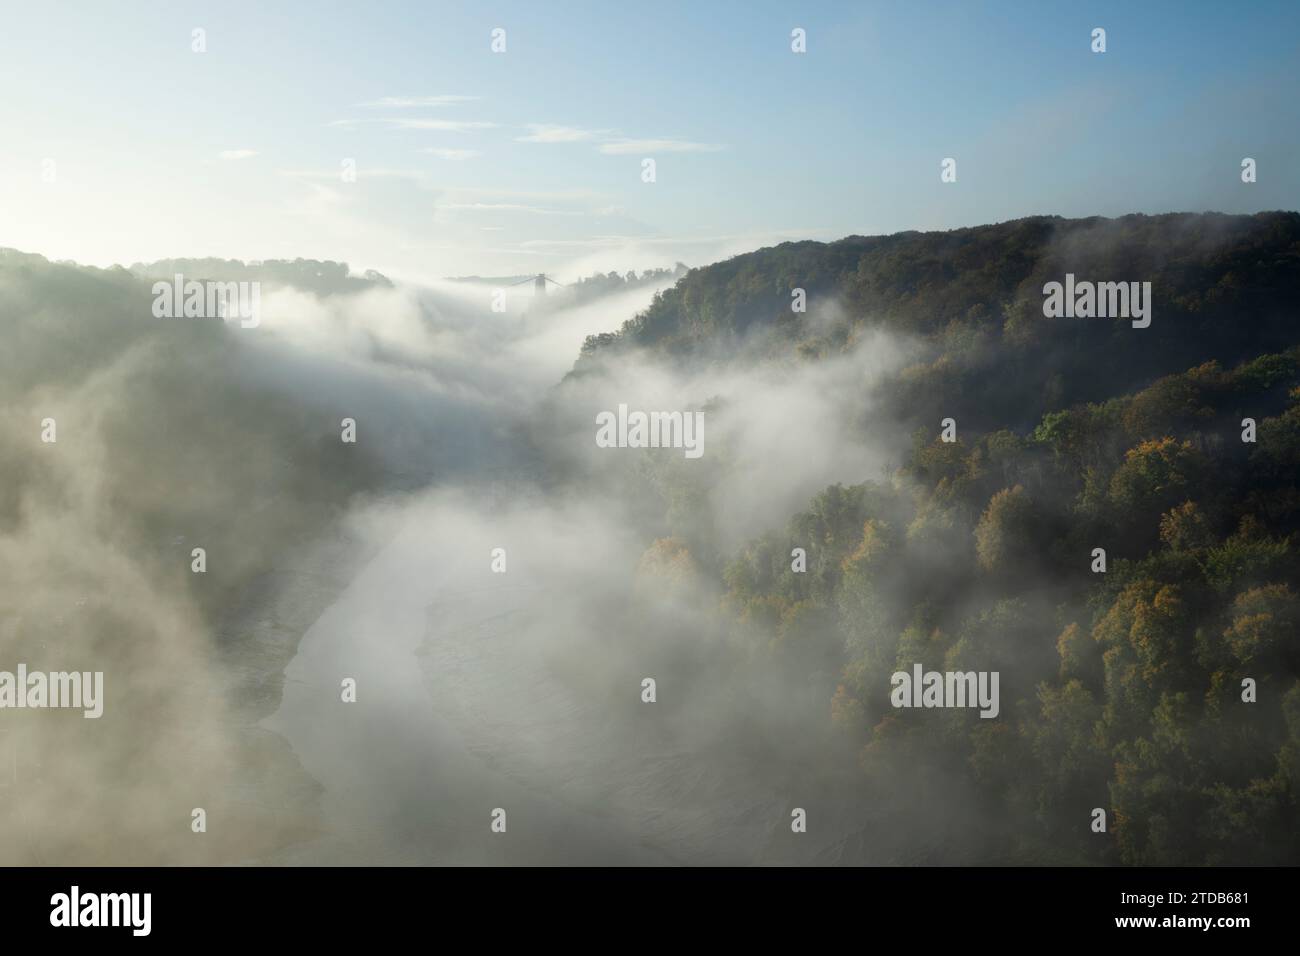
left=579, top=212, right=1300, bottom=428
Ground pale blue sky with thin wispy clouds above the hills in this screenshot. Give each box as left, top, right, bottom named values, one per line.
left=0, top=0, right=1300, bottom=280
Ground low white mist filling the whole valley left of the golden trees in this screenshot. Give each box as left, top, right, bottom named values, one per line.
left=0, top=254, right=910, bottom=864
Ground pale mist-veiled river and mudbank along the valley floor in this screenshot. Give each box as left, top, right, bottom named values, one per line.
left=245, top=280, right=814, bottom=865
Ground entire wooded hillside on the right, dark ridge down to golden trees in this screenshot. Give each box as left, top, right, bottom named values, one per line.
left=569, top=213, right=1300, bottom=864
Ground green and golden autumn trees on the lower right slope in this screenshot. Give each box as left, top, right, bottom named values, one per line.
left=727, top=338, right=1300, bottom=865
